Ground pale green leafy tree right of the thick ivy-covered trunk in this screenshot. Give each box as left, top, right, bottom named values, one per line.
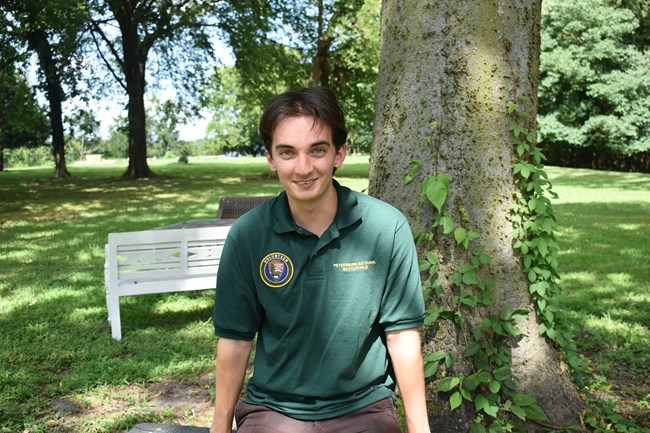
left=539, top=0, right=650, bottom=171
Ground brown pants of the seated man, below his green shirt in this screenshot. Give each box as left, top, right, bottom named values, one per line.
left=235, top=398, right=400, bottom=433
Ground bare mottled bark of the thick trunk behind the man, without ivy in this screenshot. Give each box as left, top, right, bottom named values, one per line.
left=369, top=0, right=582, bottom=432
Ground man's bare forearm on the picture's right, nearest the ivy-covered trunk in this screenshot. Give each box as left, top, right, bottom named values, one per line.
left=386, top=328, right=430, bottom=433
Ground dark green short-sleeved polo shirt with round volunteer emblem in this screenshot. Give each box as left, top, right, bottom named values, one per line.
left=214, top=182, right=424, bottom=420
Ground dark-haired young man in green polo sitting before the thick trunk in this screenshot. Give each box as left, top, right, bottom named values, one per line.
left=210, top=87, right=429, bottom=433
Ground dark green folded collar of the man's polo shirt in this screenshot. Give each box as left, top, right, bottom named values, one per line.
left=272, top=180, right=361, bottom=233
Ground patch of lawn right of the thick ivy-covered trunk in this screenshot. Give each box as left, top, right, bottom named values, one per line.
left=547, top=167, right=650, bottom=431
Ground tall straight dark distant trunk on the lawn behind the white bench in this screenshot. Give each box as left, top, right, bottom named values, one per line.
left=110, top=0, right=154, bottom=179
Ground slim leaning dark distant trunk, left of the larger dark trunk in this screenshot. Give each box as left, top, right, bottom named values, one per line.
left=29, top=29, right=70, bottom=178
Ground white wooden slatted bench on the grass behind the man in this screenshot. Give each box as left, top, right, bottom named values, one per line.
left=104, top=224, right=230, bottom=340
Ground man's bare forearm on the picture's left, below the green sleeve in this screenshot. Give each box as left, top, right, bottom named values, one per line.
left=210, top=338, right=253, bottom=433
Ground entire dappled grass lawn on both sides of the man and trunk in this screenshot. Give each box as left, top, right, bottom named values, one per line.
left=0, top=156, right=650, bottom=433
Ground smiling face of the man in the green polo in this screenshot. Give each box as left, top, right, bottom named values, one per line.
left=266, top=116, right=347, bottom=204
